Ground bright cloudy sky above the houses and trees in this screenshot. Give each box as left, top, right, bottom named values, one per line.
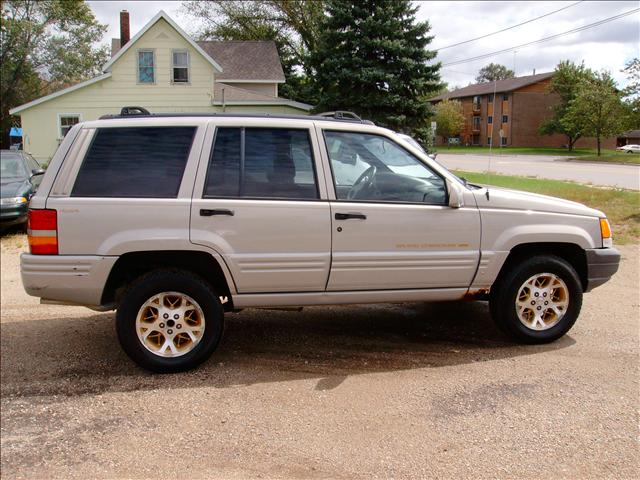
left=88, top=0, right=640, bottom=87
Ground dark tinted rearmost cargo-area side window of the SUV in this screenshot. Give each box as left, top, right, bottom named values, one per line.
left=71, top=127, right=196, bottom=198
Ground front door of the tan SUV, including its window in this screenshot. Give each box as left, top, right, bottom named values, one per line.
left=324, top=130, right=480, bottom=291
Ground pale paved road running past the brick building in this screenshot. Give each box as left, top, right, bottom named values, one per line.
left=438, top=152, right=640, bottom=190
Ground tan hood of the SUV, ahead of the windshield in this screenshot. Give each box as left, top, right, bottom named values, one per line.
left=473, top=187, right=605, bottom=217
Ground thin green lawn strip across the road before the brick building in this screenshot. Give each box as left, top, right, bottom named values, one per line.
left=437, top=146, right=640, bottom=165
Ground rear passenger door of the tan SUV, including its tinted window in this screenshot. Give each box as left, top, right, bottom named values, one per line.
left=190, top=119, right=331, bottom=293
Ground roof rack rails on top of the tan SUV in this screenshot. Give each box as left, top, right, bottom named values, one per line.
left=100, top=106, right=375, bottom=125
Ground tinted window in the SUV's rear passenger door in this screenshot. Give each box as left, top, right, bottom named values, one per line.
left=204, top=128, right=318, bottom=200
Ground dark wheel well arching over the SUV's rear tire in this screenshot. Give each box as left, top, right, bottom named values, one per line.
left=102, top=250, right=233, bottom=310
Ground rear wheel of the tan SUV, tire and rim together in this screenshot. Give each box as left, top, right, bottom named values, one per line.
left=116, top=270, right=224, bottom=373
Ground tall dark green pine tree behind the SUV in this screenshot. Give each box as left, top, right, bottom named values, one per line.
left=311, top=0, right=441, bottom=132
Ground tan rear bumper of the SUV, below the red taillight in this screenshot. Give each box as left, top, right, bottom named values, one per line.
left=20, top=253, right=118, bottom=306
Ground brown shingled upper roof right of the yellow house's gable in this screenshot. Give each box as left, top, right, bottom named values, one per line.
left=197, top=41, right=285, bottom=83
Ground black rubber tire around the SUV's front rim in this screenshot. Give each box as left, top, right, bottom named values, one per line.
left=489, top=255, right=582, bottom=344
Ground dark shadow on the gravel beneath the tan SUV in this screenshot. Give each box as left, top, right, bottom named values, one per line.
left=1, top=302, right=575, bottom=399
